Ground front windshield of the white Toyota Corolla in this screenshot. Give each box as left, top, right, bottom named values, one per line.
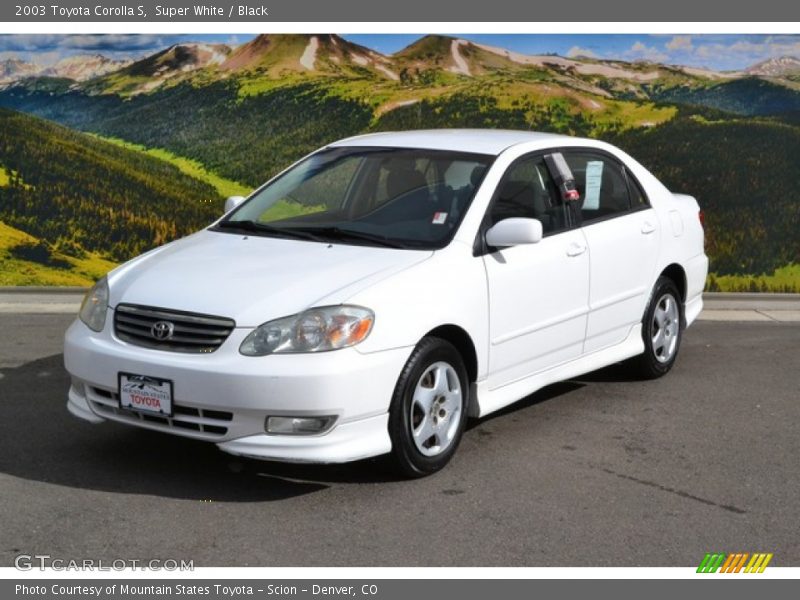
left=214, top=147, right=492, bottom=249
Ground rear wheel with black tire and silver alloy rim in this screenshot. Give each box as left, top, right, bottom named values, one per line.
left=634, top=277, right=684, bottom=379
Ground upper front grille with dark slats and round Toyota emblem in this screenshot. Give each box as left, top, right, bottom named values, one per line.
left=114, top=304, right=236, bottom=354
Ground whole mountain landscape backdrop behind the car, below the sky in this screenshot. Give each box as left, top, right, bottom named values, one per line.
left=0, top=35, right=800, bottom=291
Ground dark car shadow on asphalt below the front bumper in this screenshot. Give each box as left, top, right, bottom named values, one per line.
left=0, top=354, right=412, bottom=502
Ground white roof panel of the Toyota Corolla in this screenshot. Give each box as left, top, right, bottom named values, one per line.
left=330, top=129, right=597, bottom=156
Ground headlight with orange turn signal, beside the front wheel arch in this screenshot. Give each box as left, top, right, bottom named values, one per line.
left=239, top=305, right=375, bottom=356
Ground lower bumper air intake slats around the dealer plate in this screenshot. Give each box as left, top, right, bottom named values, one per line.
left=86, top=386, right=233, bottom=438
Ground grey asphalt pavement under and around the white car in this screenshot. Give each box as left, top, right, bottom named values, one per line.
left=0, top=314, right=800, bottom=566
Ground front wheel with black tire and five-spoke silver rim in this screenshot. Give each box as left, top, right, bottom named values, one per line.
left=389, top=337, right=469, bottom=477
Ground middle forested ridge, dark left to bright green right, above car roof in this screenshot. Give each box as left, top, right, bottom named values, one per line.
left=0, top=76, right=676, bottom=186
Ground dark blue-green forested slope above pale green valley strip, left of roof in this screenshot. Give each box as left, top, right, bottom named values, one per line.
left=0, top=82, right=372, bottom=186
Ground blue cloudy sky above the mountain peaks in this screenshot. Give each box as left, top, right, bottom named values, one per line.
left=0, top=34, right=800, bottom=70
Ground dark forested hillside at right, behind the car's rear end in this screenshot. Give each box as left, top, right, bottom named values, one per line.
left=612, top=113, right=800, bottom=275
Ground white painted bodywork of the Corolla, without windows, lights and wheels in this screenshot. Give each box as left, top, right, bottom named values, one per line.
left=64, top=130, right=708, bottom=462
